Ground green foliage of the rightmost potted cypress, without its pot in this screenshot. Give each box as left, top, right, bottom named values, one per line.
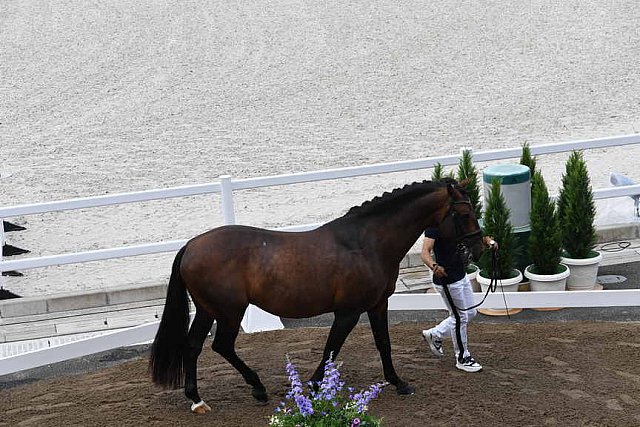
left=558, top=151, right=596, bottom=259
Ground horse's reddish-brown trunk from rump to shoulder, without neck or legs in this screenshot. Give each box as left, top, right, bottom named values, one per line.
left=181, top=225, right=388, bottom=317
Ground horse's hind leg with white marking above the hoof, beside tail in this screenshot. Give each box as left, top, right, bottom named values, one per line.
left=183, top=309, right=214, bottom=413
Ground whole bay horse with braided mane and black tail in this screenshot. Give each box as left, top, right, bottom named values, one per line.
left=149, top=179, right=482, bottom=413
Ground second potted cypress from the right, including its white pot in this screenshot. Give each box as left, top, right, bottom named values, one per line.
left=524, top=171, right=570, bottom=291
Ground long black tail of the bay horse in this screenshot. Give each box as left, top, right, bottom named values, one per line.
left=149, top=247, right=189, bottom=388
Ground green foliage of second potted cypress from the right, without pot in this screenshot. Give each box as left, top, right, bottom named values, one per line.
left=528, top=171, right=562, bottom=274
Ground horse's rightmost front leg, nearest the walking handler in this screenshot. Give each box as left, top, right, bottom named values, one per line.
left=367, top=298, right=415, bottom=394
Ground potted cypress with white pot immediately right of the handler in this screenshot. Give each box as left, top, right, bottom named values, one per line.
left=477, top=178, right=522, bottom=292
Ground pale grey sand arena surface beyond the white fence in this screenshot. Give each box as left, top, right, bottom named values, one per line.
left=0, top=0, right=640, bottom=296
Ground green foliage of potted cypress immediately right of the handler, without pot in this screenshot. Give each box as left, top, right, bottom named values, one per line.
left=479, top=178, right=520, bottom=279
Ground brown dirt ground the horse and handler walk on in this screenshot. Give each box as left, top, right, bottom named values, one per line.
left=0, top=322, right=640, bottom=427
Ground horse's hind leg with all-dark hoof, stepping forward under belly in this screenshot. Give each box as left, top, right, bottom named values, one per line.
left=211, top=318, right=269, bottom=403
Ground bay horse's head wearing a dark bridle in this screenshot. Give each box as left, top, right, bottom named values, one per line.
left=439, top=180, right=484, bottom=262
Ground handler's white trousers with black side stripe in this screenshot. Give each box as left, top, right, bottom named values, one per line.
left=431, top=275, right=477, bottom=357
